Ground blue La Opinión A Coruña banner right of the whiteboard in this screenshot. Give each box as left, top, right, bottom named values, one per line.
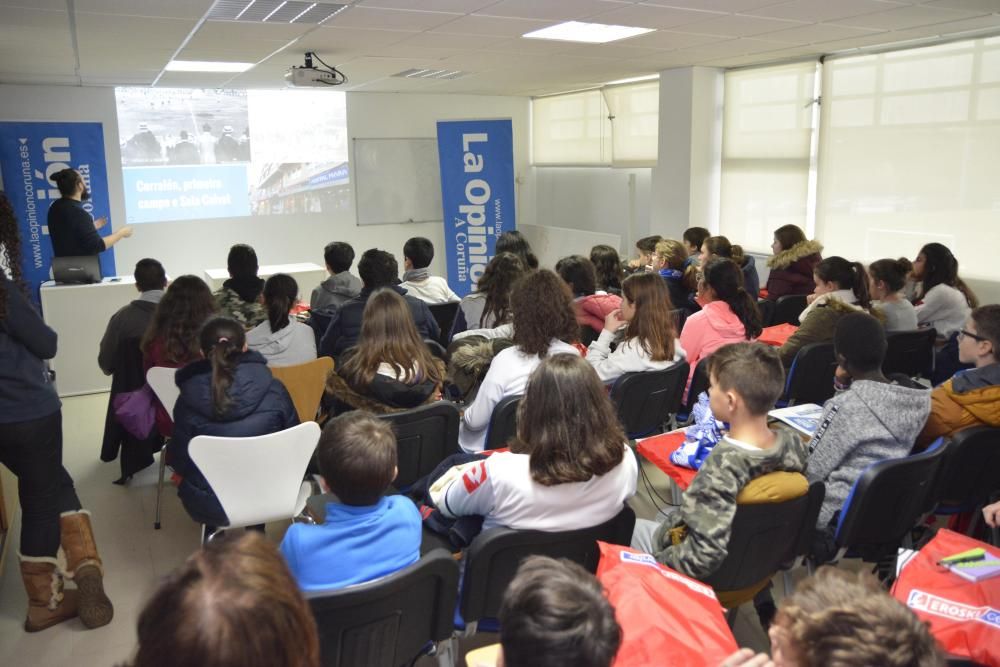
left=437, top=119, right=516, bottom=296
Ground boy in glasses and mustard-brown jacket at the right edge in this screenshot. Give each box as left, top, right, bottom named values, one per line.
left=917, top=304, right=1000, bottom=449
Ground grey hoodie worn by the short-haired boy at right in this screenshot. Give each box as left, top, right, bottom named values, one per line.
left=806, top=380, right=931, bottom=529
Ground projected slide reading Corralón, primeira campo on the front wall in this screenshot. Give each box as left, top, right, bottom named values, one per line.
left=115, top=88, right=350, bottom=224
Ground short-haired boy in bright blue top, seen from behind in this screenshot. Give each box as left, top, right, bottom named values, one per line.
left=281, top=411, right=421, bottom=591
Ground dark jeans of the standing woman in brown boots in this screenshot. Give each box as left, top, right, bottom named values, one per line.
left=0, top=410, right=80, bottom=558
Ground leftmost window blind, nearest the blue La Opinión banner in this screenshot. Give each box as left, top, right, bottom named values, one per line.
left=531, top=90, right=611, bottom=166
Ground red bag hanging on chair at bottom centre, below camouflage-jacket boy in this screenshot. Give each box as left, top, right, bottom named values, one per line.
left=597, top=542, right=739, bottom=667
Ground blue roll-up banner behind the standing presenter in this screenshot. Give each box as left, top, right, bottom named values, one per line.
left=0, top=122, right=115, bottom=303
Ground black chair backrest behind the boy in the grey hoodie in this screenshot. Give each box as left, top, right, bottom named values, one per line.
left=836, top=439, right=947, bottom=558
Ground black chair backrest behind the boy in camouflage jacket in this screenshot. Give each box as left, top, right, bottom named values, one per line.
left=704, top=473, right=825, bottom=591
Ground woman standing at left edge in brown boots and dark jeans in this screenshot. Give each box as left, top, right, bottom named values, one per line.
left=0, top=193, right=114, bottom=632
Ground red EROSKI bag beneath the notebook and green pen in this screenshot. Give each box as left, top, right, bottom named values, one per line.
left=892, top=529, right=1000, bottom=667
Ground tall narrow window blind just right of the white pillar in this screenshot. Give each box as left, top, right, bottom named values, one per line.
left=720, top=62, right=819, bottom=254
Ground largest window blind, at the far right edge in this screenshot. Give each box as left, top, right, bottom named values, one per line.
left=816, top=38, right=1000, bottom=278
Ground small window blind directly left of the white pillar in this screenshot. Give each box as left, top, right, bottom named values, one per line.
left=601, top=80, right=660, bottom=167
